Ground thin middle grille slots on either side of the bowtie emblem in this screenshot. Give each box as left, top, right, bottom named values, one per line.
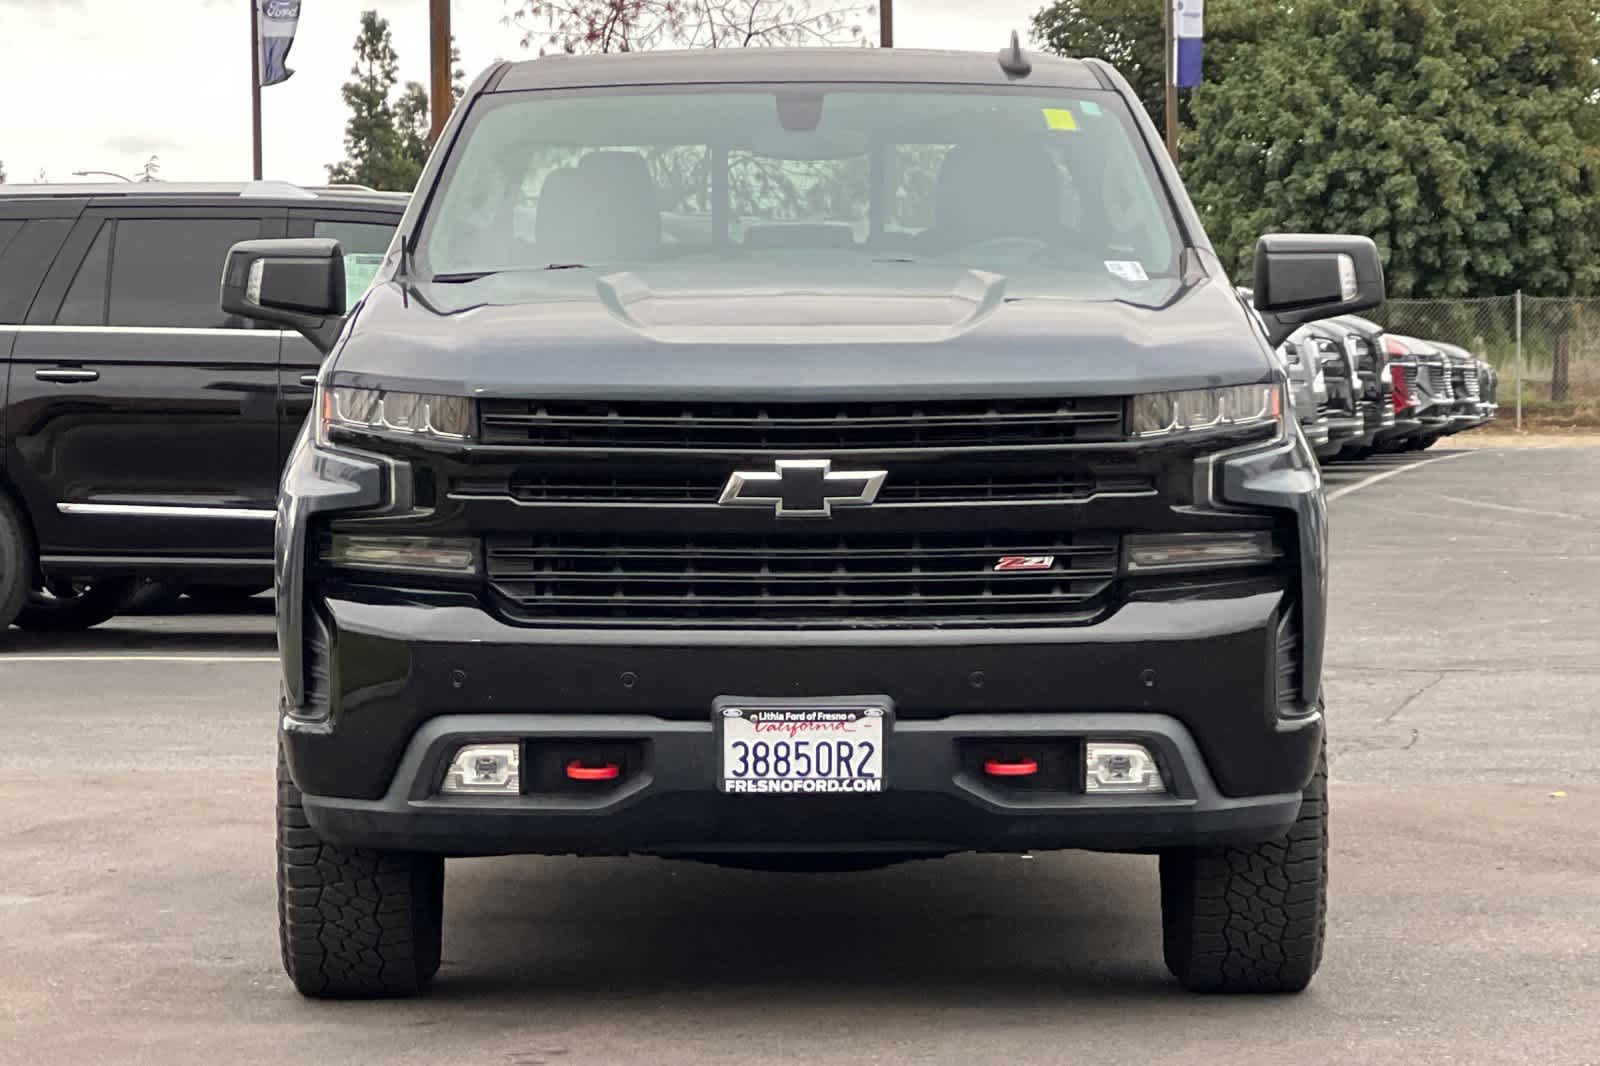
left=451, top=469, right=1155, bottom=506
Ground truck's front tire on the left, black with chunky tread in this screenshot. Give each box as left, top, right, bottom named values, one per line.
left=278, top=744, right=445, bottom=999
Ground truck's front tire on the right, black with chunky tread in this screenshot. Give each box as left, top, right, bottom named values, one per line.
left=1162, top=746, right=1328, bottom=992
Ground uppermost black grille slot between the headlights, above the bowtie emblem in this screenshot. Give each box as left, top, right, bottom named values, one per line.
left=478, top=397, right=1125, bottom=451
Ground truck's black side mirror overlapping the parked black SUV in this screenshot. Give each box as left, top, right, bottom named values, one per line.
left=222, top=237, right=344, bottom=355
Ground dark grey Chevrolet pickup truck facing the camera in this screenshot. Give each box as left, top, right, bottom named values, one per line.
left=222, top=48, right=1382, bottom=996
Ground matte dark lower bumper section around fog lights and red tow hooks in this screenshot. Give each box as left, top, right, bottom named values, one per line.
left=304, top=714, right=1322, bottom=856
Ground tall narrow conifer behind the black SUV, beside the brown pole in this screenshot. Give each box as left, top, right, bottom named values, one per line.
left=328, top=11, right=466, bottom=192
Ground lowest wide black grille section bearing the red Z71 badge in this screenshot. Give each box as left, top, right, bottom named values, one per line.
left=486, top=531, right=1120, bottom=626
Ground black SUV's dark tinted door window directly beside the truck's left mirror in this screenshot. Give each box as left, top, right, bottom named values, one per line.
left=109, top=218, right=261, bottom=328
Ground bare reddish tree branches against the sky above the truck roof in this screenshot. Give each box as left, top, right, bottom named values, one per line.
left=509, top=0, right=877, bottom=56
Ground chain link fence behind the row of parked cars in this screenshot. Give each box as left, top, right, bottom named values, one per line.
left=1371, top=296, right=1600, bottom=427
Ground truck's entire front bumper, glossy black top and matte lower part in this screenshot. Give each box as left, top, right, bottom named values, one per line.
left=282, top=586, right=1323, bottom=855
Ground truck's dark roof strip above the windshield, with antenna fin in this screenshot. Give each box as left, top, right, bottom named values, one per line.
left=488, top=42, right=1110, bottom=91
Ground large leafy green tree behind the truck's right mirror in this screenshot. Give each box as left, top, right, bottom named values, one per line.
left=1184, top=0, right=1600, bottom=296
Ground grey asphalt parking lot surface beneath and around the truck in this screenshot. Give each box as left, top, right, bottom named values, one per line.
left=0, top=442, right=1600, bottom=1066
